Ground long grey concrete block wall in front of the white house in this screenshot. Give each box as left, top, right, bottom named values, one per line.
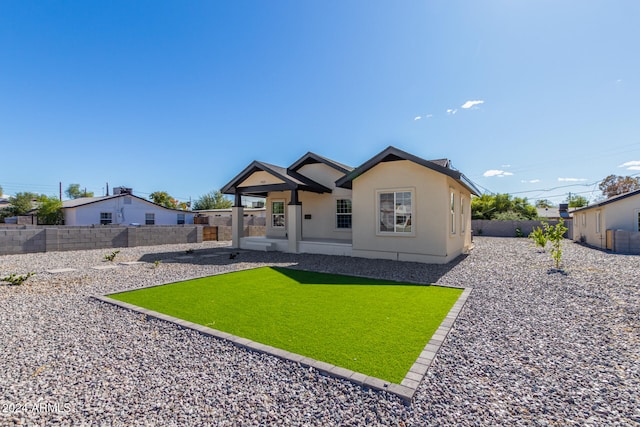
left=0, top=225, right=202, bottom=255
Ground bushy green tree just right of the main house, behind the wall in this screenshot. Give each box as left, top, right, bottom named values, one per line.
left=471, top=194, right=538, bottom=220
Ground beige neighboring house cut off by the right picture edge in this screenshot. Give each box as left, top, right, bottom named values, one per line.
left=573, top=190, right=640, bottom=249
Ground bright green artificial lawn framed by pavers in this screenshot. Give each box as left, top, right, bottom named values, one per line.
left=110, top=267, right=462, bottom=383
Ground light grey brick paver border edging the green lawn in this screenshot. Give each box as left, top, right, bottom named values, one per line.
left=91, top=285, right=473, bottom=404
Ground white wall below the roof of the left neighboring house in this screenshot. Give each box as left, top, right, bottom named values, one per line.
left=64, top=197, right=195, bottom=225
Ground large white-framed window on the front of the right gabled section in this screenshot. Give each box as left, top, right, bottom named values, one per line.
left=378, top=191, right=413, bottom=233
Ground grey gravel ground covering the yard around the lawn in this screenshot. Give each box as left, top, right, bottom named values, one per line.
left=0, top=237, right=640, bottom=426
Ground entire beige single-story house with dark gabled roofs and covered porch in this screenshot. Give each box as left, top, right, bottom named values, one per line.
left=221, top=147, right=479, bottom=264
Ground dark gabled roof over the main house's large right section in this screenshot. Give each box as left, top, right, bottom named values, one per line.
left=336, top=146, right=480, bottom=196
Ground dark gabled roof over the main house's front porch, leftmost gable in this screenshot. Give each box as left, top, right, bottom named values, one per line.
left=221, top=160, right=331, bottom=197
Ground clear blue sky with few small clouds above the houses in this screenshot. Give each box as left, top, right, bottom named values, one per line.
left=0, top=0, right=640, bottom=206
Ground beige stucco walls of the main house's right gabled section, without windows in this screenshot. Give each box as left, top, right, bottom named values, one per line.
left=352, top=160, right=471, bottom=263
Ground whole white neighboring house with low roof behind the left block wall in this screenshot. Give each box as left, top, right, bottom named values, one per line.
left=62, top=193, right=195, bottom=225
